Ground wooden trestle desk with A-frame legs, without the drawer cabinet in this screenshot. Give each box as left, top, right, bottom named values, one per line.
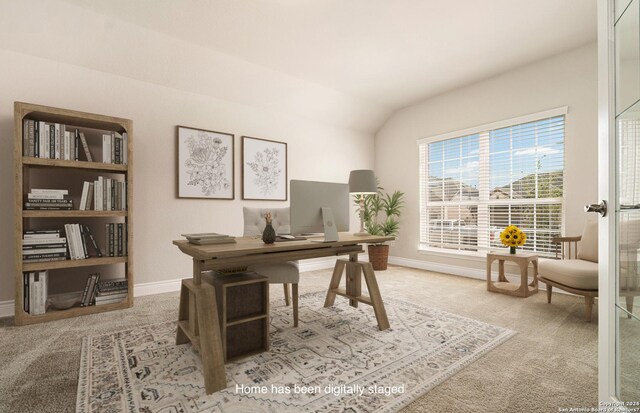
left=173, top=233, right=394, bottom=394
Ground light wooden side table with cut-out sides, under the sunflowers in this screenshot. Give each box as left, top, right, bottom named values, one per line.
left=487, top=251, right=538, bottom=297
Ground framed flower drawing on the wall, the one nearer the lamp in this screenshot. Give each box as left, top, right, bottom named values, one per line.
left=242, top=136, right=289, bottom=201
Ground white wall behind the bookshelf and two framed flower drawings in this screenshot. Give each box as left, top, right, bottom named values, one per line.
left=0, top=1, right=374, bottom=302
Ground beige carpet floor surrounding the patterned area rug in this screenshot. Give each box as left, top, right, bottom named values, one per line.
left=0, top=267, right=597, bottom=413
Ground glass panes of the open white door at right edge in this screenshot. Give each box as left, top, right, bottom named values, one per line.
left=614, top=0, right=640, bottom=402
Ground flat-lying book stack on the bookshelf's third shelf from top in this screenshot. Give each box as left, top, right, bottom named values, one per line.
left=22, top=229, right=67, bottom=262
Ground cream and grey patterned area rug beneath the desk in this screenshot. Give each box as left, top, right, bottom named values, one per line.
left=76, top=292, right=515, bottom=413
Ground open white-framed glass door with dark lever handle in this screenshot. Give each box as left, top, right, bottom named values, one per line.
left=598, top=0, right=640, bottom=400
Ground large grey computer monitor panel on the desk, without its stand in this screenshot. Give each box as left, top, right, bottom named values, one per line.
left=289, top=179, right=349, bottom=235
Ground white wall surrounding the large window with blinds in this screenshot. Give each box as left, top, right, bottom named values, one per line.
left=375, top=43, right=597, bottom=269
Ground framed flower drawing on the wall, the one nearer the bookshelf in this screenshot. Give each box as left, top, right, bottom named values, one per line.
left=177, top=126, right=234, bottom=199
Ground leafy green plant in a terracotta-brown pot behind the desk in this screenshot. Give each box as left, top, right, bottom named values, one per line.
left=354, top=186, right=404, bottom=271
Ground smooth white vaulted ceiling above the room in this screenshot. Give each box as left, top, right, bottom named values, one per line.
left=60, top=0, right=596, bottom=111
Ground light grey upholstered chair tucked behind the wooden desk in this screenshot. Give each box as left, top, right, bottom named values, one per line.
left=242, top=207, right=300, bottom=327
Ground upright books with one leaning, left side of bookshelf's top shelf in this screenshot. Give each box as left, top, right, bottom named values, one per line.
left=22, top=119, right=92, bottom=162
